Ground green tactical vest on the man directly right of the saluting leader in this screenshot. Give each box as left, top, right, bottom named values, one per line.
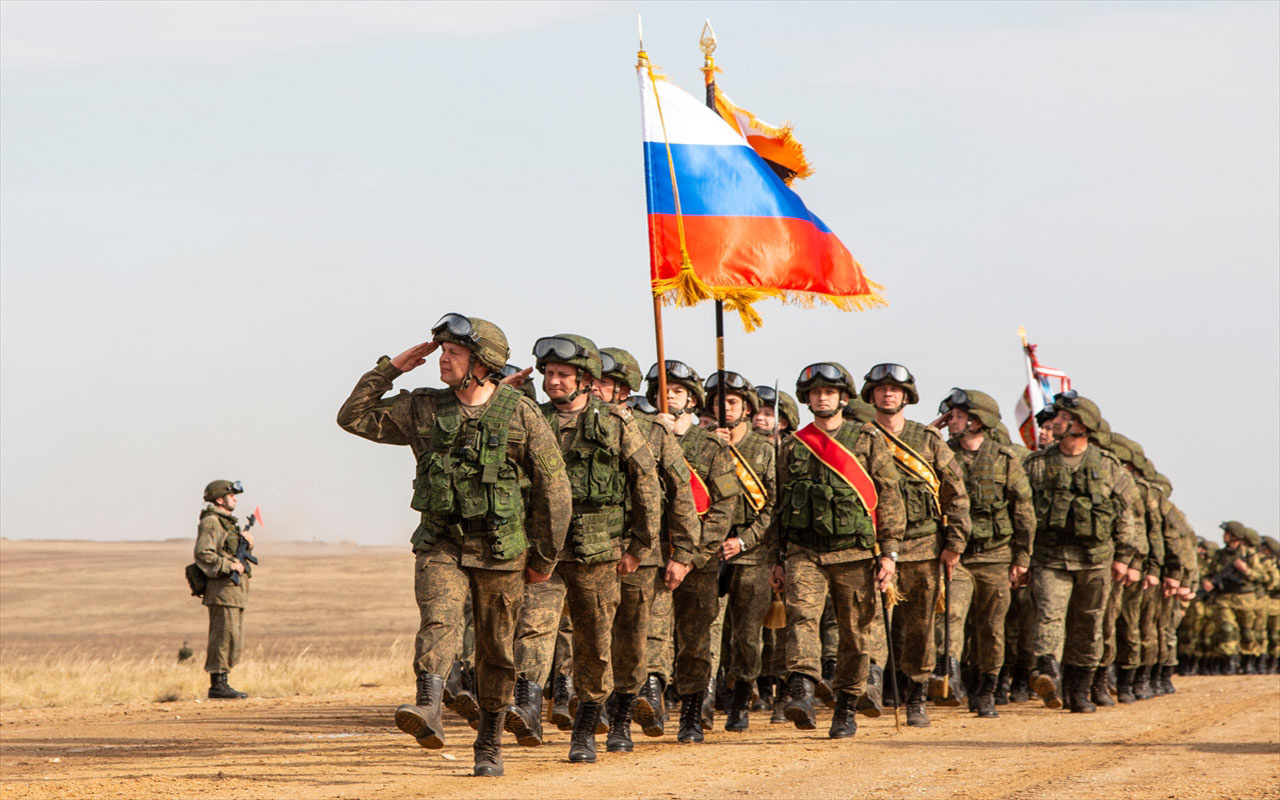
left=543, top=397, right=627, bottom=564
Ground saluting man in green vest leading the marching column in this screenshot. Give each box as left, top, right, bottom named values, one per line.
left=338, top=314, right=571, bottom=776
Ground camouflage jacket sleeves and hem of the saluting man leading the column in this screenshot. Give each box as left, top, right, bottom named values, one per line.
left=338, top=356, right=572, bottom=573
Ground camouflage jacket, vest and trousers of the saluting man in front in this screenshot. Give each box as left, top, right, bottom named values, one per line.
left=338, top=356, right=571, bottom=722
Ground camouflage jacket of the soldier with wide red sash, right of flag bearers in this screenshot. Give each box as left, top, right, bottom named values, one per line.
left=769, top=419, right=906, bottom=564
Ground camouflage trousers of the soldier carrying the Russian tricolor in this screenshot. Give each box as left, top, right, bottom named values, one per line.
left=671, top=561, right=724, bottom=695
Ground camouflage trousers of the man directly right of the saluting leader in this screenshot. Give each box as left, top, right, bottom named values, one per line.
left=517, top=561, right=620, bottom=701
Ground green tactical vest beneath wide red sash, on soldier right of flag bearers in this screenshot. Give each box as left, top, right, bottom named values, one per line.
left=776, top=420, right=876, bottom=553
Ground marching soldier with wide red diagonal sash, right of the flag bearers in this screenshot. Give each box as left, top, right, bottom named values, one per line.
left=772, top=361, right=906, bottom=739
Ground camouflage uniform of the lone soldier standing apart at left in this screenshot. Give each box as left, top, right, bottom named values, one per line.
left=196, top=503, right=250, bottom=680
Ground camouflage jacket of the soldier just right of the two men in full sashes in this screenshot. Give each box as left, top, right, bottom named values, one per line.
left=947, top=436, right=1036, bottom=567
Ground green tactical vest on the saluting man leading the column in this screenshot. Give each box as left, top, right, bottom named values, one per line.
left=410, top=387, right=529, bottom=561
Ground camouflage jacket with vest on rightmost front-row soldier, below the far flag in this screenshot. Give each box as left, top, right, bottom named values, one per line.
left=1025, top=444, right=1146, bottom=571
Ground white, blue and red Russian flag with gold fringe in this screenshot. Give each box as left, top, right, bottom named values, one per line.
left=637, top=61, right=884, bottom=310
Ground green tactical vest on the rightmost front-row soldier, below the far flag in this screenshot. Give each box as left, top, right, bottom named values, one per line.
left=1034, top=445, right=1117, bottom=548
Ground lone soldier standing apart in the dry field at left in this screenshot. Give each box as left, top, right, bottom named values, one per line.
left=196, top=480, right=253, bottom=700
